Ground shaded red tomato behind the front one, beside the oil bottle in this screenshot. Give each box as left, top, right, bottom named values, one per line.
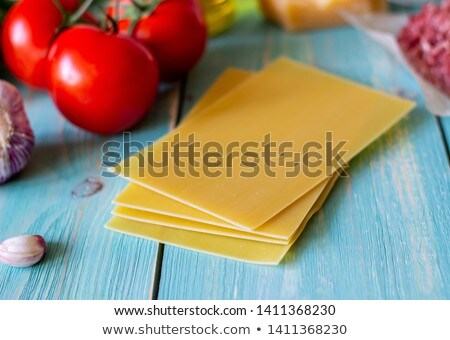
left=110, top=0, right=207, bottom=81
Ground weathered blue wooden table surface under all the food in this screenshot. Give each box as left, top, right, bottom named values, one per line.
left=0, top=2, right=450, bottom=299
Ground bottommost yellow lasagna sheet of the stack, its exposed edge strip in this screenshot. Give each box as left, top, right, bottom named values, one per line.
left=105, top=171, right=329, bottom=265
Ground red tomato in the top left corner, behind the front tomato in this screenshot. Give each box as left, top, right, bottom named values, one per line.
left=2, top=0, right=79, bottom=89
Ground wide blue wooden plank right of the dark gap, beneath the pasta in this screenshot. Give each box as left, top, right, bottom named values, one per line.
left=159, top=4, right=450, bottom=299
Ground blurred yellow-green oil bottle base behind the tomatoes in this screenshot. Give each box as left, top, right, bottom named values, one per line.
left=200, top=0, right=236, bottom=36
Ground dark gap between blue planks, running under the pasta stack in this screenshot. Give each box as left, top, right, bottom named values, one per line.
left=149, top=75, right=188, bottom=300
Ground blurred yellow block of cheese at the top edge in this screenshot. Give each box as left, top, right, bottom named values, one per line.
left=259, top=0, right=386, bottom=31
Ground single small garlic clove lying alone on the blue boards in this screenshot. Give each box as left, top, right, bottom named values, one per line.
left=0, top=235, right=47, bottom=267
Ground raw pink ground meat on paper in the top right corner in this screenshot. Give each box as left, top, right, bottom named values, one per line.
left=398, top=0, right=450, bottom=96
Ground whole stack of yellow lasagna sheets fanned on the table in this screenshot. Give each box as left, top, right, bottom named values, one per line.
left=106, top=58, right=414, bottom=265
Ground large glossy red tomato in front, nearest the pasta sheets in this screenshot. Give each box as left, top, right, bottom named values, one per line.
left=47, top=25, right=158, bottom=134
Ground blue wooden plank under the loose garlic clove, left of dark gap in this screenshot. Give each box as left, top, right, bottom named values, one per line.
left=0, top=71, right=179, bottom=299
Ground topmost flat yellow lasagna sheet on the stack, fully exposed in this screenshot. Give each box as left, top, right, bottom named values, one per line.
left=116, top=58, right=414, bottom=229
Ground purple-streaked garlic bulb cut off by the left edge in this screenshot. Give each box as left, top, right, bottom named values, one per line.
left=0, top=80, right=34, bottom=184
